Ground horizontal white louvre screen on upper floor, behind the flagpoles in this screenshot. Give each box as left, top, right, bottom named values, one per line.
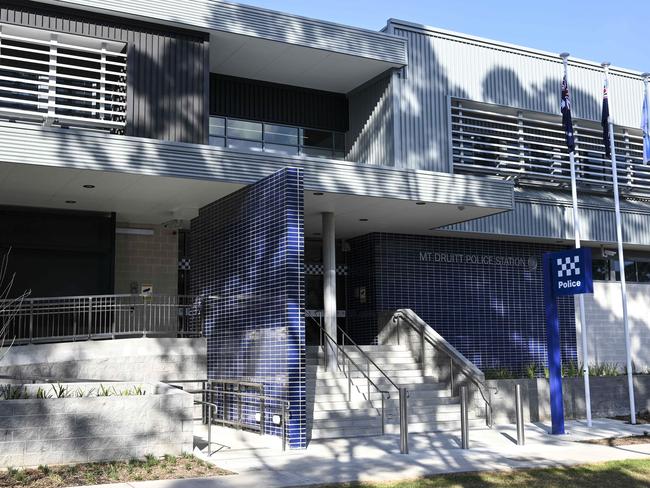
left=450, top=100, right=650, bottom=198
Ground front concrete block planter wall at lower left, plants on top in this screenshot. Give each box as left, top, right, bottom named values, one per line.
left=0, top=383, right=193, bottom=467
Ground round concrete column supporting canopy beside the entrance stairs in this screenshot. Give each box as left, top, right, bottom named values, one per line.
left=323, top=212, right=337, bottom=371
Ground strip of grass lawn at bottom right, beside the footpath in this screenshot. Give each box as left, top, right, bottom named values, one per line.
left=320, top=459, right=650, bottom=488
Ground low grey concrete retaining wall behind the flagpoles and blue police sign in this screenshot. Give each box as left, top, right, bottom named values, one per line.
left=487, top=375, right=650, bottom=423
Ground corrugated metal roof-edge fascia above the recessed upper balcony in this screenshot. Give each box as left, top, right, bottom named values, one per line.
left=44, top=0, right=406, bottom=65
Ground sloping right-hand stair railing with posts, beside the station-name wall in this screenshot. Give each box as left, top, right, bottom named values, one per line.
left=393, top=309, right=492, bottom=428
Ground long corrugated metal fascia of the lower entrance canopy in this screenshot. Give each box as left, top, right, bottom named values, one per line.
left=0, top=123, right=513, bottom=210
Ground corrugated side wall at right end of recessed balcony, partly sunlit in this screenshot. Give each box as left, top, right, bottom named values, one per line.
left=345, top=73, right=395, bottom=166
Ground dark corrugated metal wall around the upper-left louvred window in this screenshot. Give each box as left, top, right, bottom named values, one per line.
left=0, top=0, right=209, bottom=143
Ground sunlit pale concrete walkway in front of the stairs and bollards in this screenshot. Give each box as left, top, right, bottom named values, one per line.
left=78, top=419, right=650, bottom=488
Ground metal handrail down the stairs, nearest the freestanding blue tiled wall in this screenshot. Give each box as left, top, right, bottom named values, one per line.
left=305, top=312, right=408, bottom=454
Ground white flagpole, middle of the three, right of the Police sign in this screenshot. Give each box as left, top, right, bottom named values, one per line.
left=602, top=63, right=636, bottom=424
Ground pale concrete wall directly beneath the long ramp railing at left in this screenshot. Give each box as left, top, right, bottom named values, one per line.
left=0, top=338, right=207, bottom=382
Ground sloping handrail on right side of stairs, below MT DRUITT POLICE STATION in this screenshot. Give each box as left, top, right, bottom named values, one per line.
left=392, top=308, right=492, bottom=427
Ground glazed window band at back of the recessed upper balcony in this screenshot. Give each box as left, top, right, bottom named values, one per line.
left=210, top=117, right=345, bottom=159
